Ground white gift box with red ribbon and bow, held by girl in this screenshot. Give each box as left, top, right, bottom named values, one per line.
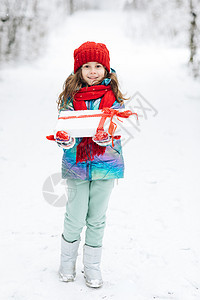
left=54, top=108, right=137, bottom=137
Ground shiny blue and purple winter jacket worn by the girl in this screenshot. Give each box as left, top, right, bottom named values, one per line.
left=62, top=78, right=124, bottom=181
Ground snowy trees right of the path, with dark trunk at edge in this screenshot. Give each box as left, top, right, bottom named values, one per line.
left=122, top=0, right=200, bottom=77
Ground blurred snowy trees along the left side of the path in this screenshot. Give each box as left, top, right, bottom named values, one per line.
left=0, top=0, right=101, bottom=62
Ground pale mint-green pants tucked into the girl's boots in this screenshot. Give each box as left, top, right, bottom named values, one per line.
left=63, top=179, right=114, bottom=247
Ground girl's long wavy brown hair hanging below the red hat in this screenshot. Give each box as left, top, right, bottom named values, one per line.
left=57, top=68, right=128, bottom=110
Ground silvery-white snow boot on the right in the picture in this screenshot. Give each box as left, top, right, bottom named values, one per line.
left=83, top=245, right=103, bottom=288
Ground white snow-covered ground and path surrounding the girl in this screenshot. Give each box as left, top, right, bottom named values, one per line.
left=0, top=11, right=200, bottom=300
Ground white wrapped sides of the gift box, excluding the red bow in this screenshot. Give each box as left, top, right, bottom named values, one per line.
left=54, top=109, right=136, bottom=137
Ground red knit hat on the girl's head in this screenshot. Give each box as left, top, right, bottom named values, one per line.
left=74, top=42, right=110, bottom=73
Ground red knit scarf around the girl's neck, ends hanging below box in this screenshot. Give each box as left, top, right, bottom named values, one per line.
left=73, top=85, right=116, bottom=163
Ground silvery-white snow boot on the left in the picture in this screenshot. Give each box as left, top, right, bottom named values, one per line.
left=58, top=236, right=80, bottom=282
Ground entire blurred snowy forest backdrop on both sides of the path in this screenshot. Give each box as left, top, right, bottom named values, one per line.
left=0, top=0, right=200, bottom=77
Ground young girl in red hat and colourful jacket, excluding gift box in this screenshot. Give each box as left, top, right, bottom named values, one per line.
left=56, top=42, right=125, bottom=288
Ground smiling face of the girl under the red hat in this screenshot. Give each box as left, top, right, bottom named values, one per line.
left=81, top=61, right=106, bottom=85
